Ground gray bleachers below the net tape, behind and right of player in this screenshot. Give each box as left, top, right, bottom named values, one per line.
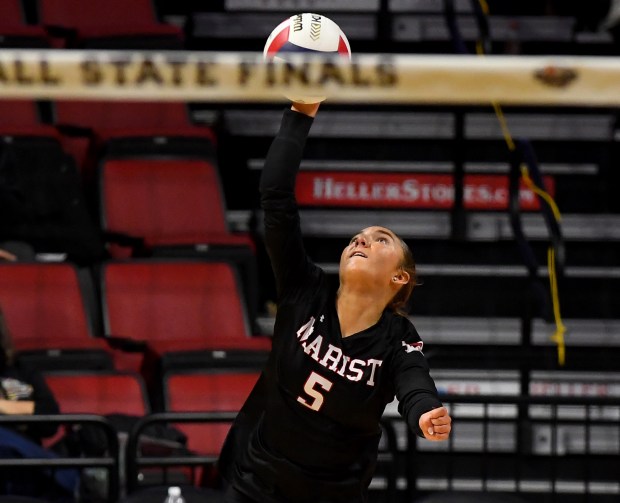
left=209, top=106, right=620, bottom=502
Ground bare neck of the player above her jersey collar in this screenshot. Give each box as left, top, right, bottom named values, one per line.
left=336, top=288, right=385, bottom=337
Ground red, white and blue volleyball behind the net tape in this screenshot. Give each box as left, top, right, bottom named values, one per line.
left=263, top=12, right=351, bottom=103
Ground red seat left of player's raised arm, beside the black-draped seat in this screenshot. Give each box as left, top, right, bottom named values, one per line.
left=99, top=157, right=258, bottom=321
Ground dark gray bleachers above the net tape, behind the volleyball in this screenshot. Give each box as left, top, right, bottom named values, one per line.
left=182, top=0, right=614, bottom=54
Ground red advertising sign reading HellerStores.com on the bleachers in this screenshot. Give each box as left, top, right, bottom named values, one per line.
left=296, top=171, right=555, bottom=210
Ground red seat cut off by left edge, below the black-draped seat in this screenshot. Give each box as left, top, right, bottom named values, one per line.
left=0, top=262, right=112, bottom=369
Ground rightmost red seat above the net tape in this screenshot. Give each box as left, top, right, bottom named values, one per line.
left=39, top=0, right=183, bottom=49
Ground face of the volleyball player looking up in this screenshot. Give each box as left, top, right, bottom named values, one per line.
left=340, top=226, right=403, bottom=282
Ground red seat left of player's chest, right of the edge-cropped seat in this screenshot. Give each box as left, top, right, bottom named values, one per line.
left=102, top=260, right=271, bottom=379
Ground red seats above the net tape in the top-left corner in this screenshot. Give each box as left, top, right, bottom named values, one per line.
left=0, top=0, right=184, bottom=49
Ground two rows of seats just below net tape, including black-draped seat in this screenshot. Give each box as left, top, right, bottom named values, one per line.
left=0, top=100, right=258, bottom=319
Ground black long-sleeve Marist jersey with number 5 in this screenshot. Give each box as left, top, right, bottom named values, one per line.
left=220, top=110, right=441, bottom=503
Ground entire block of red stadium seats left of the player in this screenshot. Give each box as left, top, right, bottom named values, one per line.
left=0, top=5, right=271, bottom=500
